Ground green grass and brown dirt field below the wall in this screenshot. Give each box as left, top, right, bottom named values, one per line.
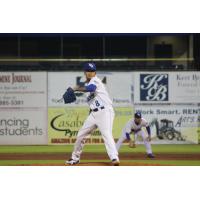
left=0, top=145, right=200, bottom=166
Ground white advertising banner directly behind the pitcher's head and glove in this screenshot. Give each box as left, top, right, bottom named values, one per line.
left=48, top=72, right=133, bottom=107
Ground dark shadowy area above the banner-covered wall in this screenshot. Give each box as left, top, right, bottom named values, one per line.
left=0, top=33, right=200, bottom=71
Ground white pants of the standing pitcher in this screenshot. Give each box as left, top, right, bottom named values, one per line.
left=72, top=108, right=119, bottom=160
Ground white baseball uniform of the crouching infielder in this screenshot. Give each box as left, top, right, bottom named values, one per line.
left=116, top=118, right=152, bottom=154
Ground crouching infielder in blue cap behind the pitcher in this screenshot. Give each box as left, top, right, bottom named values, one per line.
left=116, top=112, right=154, bottom=158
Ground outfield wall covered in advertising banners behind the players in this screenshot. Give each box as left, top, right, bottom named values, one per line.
left=0, top=72, right=200, bottom=145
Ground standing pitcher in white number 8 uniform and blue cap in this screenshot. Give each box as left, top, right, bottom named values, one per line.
left=66, top=63, right=119, bottom=165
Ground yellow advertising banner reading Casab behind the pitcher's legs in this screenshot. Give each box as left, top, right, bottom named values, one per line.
left=48, top=107, right=133, bottom=144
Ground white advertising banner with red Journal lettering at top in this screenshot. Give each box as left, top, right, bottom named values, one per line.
left=0, top=72, right=47, bottom=108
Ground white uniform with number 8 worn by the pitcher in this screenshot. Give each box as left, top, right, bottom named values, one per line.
left=72, top=76, right=119, bottom=160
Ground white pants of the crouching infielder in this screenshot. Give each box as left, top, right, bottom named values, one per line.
left=116, top=130, right=152, bottom=154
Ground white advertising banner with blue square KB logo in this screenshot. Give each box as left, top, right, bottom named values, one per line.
left=133, top=72, right=200, bottom=104
